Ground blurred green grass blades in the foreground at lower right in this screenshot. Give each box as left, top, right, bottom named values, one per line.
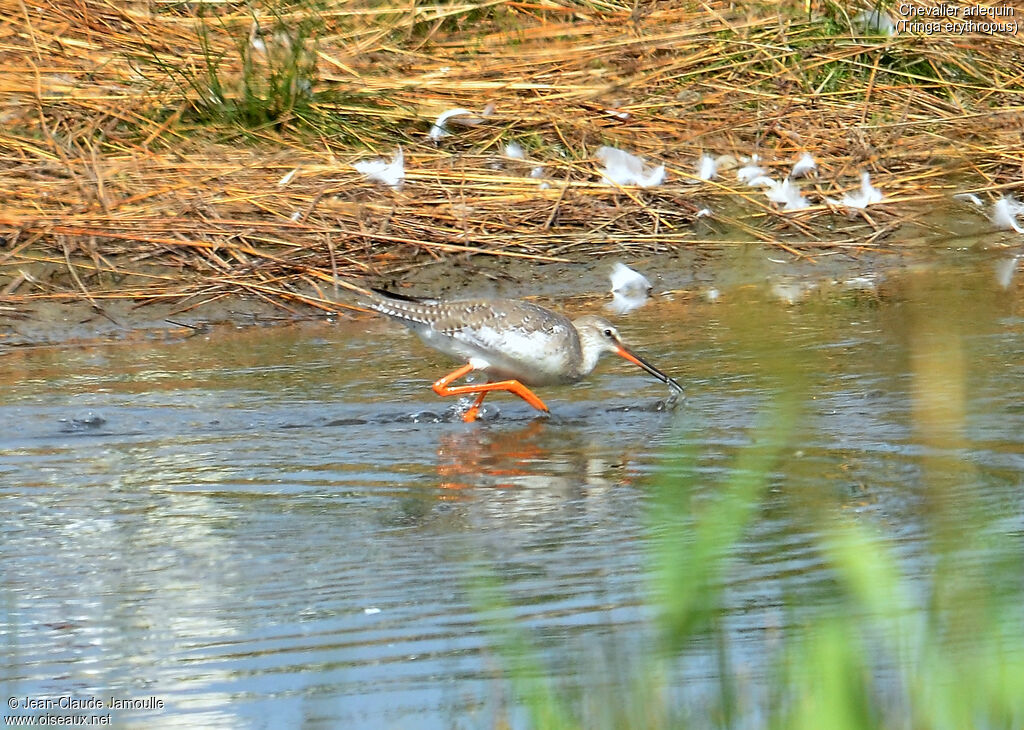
left=477, top=282, right=1024, bottom=730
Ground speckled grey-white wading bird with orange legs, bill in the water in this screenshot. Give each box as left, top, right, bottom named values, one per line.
left=364, top=291, right=683, bottom=423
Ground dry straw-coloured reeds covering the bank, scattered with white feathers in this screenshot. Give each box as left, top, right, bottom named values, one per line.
left=0, top=0, right=1024, bottom=307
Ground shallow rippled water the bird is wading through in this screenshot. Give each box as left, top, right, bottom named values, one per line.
left=0, top=256, right=1024, bottom=728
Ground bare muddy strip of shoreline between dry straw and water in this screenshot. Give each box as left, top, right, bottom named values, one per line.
left=0, top=231, right=1019, bottom=351
